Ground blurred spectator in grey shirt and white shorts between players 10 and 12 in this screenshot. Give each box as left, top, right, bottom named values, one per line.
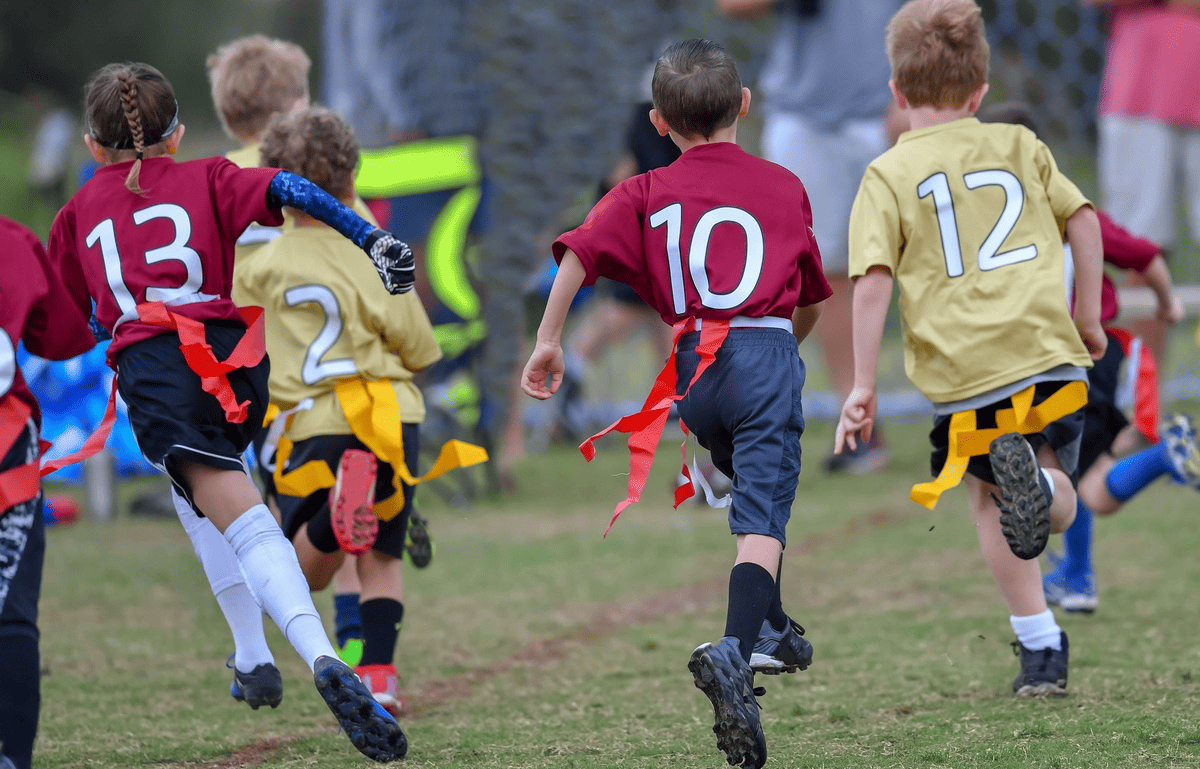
left=718, top=0, right=902, bottom=473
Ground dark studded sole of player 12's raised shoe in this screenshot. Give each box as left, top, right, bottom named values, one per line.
left=989, top=433, right=1050, bottom=560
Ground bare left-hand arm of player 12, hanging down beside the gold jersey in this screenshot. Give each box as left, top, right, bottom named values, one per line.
left=833, top=265, right=893, bottom=453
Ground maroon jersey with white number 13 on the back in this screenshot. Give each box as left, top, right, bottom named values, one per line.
left=50, top=157, right=283, bottom=366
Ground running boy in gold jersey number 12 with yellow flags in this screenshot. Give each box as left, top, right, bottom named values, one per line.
left=834, top=0, right=1106, bottom=697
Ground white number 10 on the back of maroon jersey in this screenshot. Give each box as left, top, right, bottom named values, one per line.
left=649, top=203, right=764, bottom=316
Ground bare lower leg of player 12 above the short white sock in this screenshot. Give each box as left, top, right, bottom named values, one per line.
left=965, top=475, right=1051, bottom=617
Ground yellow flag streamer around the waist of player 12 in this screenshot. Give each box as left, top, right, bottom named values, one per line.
left=908, top=382, right=1087, bottom=510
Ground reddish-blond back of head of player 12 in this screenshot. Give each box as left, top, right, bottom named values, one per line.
left=887, top=0, right=990, bottom=108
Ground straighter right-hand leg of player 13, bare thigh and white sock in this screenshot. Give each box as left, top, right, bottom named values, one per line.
left=180, top=462, right=337, bottom=668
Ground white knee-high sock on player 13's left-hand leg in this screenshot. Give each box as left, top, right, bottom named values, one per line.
left=170, top=488, right=275, bottom=673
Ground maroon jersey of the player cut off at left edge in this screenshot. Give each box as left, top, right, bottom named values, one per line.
left=0, top=216, right=96, bottom=431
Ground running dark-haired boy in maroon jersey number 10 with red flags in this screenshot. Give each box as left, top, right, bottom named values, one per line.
left=521, top=40, right=829, bottom=768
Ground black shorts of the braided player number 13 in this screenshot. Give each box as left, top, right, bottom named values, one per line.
left=116, top=323, right=271, bottom=506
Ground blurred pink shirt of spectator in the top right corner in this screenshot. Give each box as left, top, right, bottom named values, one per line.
left=1099, top=5, right=1200, bottom=128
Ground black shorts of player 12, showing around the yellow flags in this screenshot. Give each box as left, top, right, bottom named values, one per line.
left=929, top=382, right=1085, bottom=486
